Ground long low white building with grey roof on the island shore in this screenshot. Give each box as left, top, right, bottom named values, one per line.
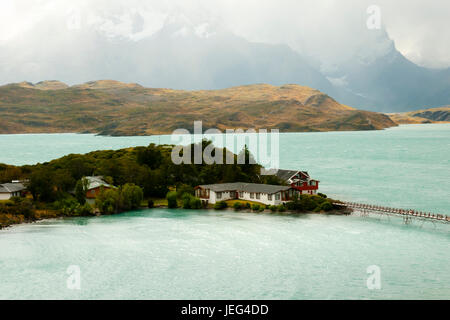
left=195, top=182, right=298, bottom=205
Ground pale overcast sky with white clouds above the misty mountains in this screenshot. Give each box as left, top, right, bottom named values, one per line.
left=0, top=0, right=450, bottom=68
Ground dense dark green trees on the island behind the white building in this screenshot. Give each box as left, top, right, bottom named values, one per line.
left=0, top=140, right=266, bottom=202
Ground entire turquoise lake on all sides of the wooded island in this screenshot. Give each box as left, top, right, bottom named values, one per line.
left=0, top=125, right=450, bottom=299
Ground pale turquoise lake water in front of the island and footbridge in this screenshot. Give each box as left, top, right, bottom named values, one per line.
left=0, top=209, right=450, bottom=299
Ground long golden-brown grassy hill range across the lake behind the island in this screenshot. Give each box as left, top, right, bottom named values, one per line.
left=0, top=80, right=396, bottom=135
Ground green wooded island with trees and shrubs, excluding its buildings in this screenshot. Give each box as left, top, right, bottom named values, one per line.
left=0, top=140, right=348, bottom=229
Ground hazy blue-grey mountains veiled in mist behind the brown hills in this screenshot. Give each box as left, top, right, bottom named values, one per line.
left=0, top=10, right=450, bottom=112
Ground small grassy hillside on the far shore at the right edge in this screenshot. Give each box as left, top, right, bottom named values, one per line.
left=389, top=106, right=450, bottom=124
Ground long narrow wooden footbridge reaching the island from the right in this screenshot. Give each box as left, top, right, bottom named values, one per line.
left=334, top=202, right=450, bottom=224
